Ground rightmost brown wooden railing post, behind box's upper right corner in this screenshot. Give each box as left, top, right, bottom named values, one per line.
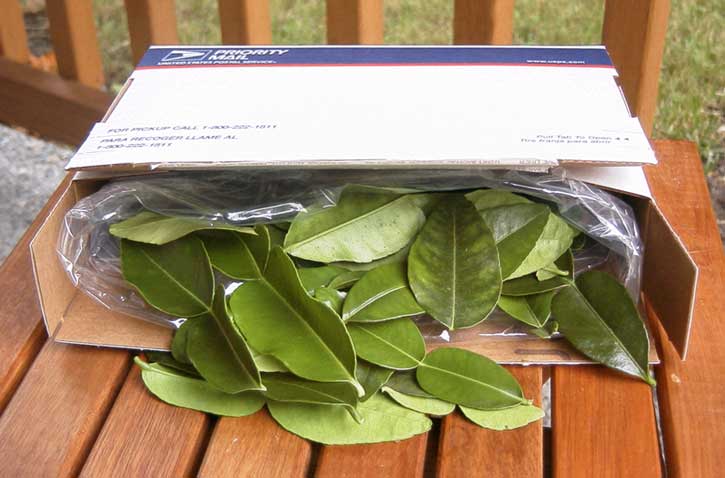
left=602, top=0, right=670, bottom=135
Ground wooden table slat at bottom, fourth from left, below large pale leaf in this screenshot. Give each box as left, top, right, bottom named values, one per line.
left=199, top=408, right=312, bottom=478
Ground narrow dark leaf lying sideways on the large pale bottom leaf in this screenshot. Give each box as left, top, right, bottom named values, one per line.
left=264, top=373, right=360, bottom=419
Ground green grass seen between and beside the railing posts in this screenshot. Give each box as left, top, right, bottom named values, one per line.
left=89, top=0, right=725, bottom=170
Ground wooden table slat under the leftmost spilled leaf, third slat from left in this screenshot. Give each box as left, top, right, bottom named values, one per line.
left=81, top=366, right=211, bottom=478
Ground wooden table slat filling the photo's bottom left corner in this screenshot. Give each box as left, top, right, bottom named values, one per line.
left=0, top=341, right=129, bottom=478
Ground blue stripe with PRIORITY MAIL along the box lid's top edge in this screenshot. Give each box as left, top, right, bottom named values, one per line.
left=138, top=46, right=612, bottom=68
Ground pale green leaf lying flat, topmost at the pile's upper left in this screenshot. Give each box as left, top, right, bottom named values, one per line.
left=109, top=211, right=254, bottom=245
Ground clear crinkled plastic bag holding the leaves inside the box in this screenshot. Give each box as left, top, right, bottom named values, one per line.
left=58, top=169, right=643, bottom=342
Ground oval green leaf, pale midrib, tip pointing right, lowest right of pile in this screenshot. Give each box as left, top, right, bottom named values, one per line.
left=416, top=348, right=528, bottom=410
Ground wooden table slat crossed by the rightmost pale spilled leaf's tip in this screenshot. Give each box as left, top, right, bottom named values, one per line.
left=437, top=366, right=544, bottom=478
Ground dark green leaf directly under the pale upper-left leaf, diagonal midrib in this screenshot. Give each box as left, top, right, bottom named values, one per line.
left=121, top=236, right=214, bottom=317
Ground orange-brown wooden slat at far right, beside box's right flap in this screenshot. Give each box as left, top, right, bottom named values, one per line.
left=645, top=141, right=725, bottom=478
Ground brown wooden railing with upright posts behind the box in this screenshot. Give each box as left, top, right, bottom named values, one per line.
left=0, top=0, right=670, bottom=143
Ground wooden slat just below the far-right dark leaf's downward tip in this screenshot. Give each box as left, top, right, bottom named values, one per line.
left=551, top=365, right=662, bottom=478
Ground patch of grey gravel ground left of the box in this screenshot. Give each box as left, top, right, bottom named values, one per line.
left=0, top=125, right=73, bottom=263
